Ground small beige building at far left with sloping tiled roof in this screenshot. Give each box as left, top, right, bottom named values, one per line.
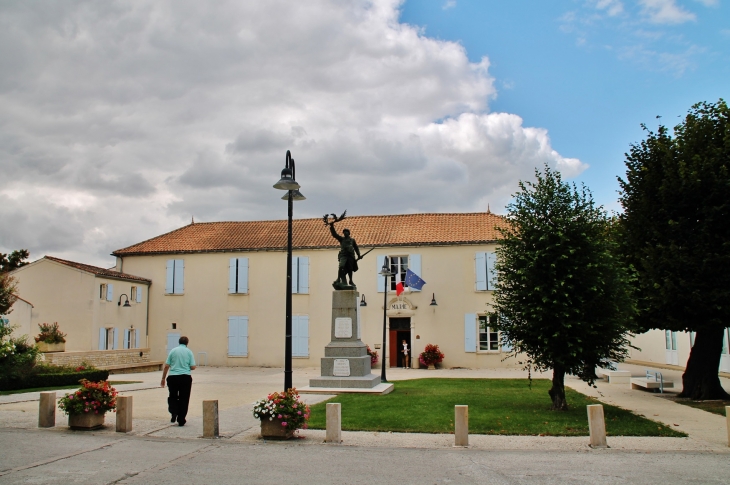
left=8, top=256, right=151, bottom=351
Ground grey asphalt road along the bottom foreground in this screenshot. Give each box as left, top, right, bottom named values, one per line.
left=0, top=429, right=730, bottom=485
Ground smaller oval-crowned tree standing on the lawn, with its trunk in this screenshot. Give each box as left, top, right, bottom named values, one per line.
left=494, top=166, right=634, bottom=410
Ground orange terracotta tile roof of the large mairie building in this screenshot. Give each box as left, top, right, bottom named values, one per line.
left=112, top=212, right=506, bottom=256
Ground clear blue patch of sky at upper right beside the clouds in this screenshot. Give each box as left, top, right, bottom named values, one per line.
left=400, top=0, right=730, bottom=210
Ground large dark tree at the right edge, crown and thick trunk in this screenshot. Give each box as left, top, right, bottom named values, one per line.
left=619, top=99, right=730, bottom=399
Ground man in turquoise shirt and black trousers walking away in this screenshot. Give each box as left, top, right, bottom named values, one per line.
left=160, top=336, right=195, bottom=426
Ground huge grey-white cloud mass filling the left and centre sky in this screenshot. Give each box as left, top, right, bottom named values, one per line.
left=0, top=0, right=586, bottom=265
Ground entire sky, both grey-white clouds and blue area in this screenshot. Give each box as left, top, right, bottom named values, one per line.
left=0, top=0, right=730, bottom=266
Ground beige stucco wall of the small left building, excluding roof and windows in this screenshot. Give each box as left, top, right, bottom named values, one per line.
left=11, top=259, right=148, bottom=351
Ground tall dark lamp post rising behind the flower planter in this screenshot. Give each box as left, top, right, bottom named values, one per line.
left=274, top=150, right=305, bottom=392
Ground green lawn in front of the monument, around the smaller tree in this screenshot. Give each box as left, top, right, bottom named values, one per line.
left=309, top=378, right=687, bottom=437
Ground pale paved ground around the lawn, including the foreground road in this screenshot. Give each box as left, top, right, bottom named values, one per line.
left=0, top=365, right=730, bottom=483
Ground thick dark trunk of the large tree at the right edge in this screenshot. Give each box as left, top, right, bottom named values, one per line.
left=679, top=327, right=730, bottom=401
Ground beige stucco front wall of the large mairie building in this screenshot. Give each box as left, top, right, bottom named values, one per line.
left=117, top=245, right=516, bottom=368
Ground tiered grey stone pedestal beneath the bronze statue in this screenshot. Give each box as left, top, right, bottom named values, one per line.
left=309, top=290, right=380, bottom=389
